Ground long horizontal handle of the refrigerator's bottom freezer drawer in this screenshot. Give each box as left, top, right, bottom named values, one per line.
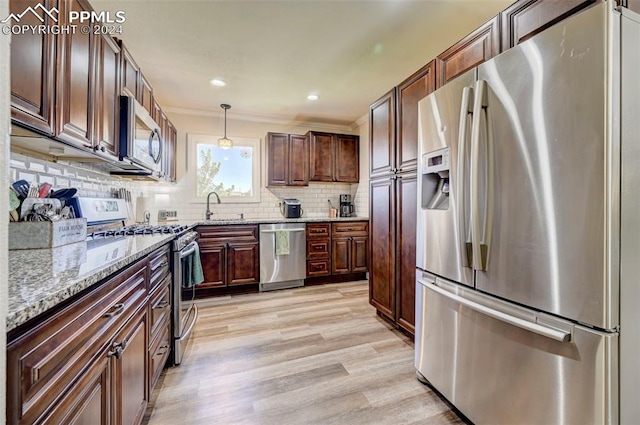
left=418, top=278, right=571, bottom=342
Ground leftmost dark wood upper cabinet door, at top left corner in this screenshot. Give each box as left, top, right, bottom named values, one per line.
left=5, top=0, right=57, bottom=135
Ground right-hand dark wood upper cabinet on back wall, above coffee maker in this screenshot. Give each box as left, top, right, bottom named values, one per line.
left=307, top=131, right=360, bottom=183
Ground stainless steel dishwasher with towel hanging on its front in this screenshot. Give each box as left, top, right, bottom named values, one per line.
left=260, top=223, right=307, bottom=291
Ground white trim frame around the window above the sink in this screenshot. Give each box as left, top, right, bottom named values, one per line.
left=187, top=133, right=262, bottom=204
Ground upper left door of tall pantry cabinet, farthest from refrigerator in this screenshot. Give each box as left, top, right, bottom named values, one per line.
left=369, top=88, right=396, bottom=178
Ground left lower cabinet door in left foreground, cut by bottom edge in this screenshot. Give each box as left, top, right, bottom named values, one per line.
left=39, top=350, right=112, bottom=425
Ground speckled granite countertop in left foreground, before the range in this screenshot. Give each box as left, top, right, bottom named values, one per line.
left=7, top=234, right=174, bottom=331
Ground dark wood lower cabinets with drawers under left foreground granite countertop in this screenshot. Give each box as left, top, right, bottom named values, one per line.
left=6, top=246, right=172, bottom=425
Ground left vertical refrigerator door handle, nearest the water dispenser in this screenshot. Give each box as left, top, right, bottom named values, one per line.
left=455, top=87, right=473, bottom=267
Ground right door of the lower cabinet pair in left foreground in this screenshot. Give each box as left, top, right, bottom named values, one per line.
left=110, top=307, right=149, bottom=425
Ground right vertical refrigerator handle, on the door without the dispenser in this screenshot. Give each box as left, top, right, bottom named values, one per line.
left=470, top=80, right=493, bottom=271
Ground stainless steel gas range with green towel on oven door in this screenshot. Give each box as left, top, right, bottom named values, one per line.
left=79, top=198, right=198, bottom=365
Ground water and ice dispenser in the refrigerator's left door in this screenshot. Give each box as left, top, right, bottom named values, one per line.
left=420, top=148, right=451, bottom=210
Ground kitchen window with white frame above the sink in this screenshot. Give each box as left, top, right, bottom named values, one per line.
left=187, top=134, right=260, bottom=203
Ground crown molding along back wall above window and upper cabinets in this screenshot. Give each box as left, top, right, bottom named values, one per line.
left=162, top=106, right=358, bottom=133
